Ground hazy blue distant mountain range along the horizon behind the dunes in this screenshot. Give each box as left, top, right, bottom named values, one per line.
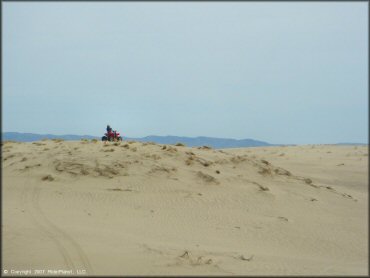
left=2, top=132, right=368, bottom=149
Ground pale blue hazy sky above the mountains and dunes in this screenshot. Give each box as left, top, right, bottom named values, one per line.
left=2, top=2, right=369, bottom=144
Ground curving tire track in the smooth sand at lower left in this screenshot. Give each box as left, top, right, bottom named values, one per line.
left=23, top=181, right=93, bottom=275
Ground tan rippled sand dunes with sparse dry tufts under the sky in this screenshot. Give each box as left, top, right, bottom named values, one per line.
left=2, top=140, right=369, bottom=276
